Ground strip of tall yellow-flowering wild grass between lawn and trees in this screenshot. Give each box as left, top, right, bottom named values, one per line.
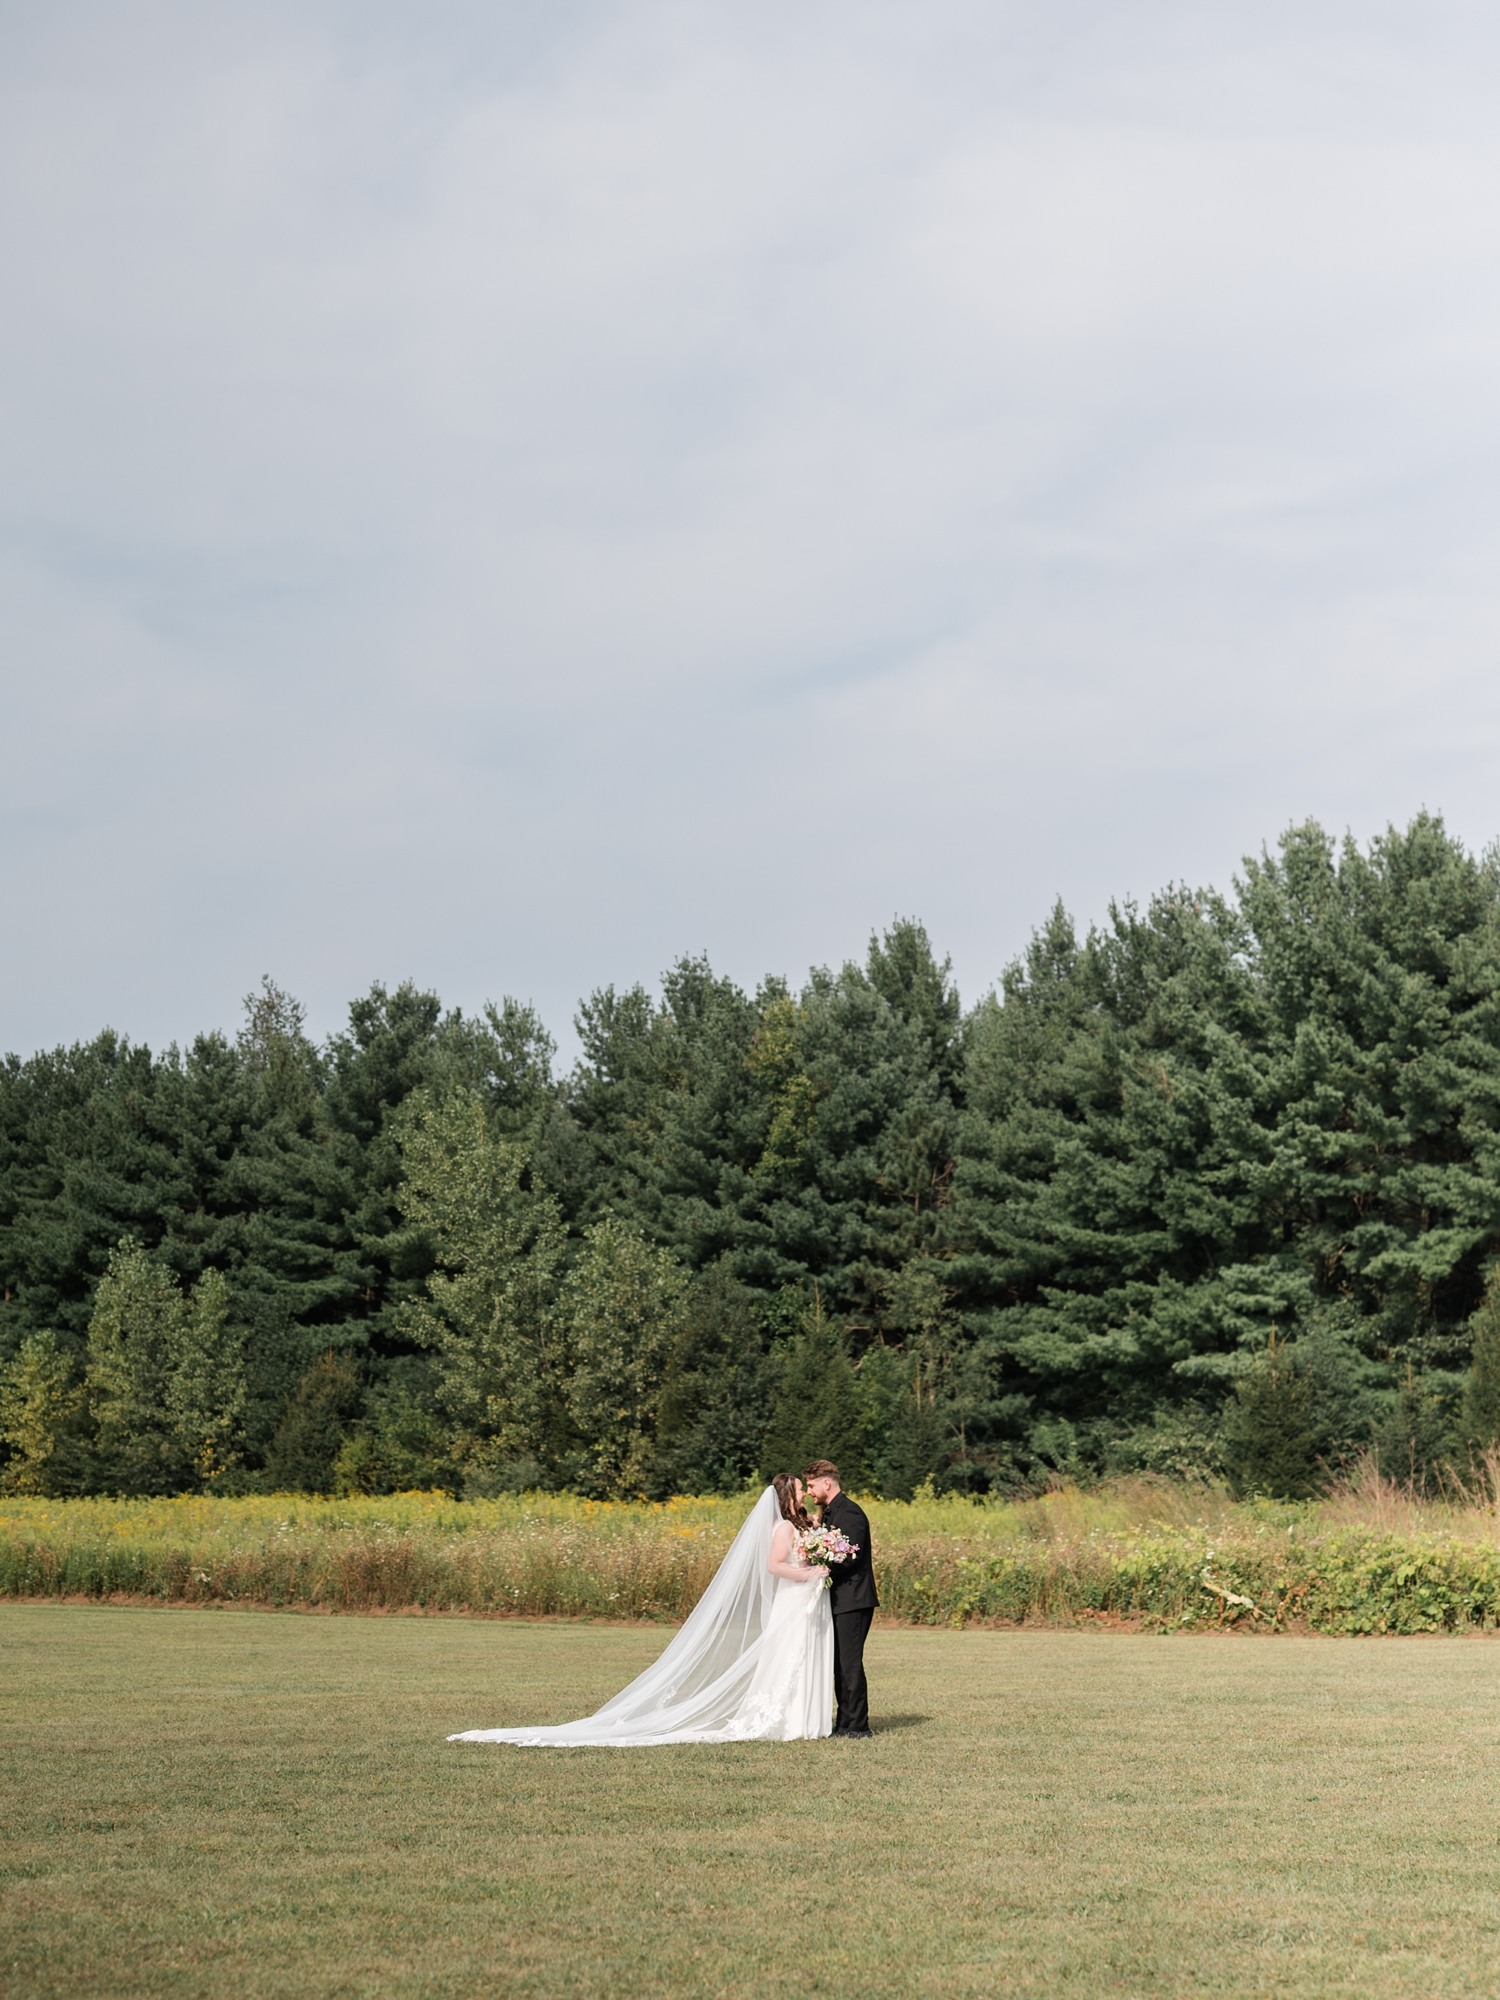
left=0, top=1466, right=1500, bottom=1632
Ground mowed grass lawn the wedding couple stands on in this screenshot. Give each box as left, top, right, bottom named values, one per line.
left=0, top=1606, right=1500, bottom=2000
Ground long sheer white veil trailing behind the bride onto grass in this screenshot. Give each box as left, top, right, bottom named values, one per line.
left=448, top=1486, right=782, bottom=1746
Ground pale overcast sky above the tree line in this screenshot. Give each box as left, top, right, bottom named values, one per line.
left=0, top=0, right=1500, bottom=1052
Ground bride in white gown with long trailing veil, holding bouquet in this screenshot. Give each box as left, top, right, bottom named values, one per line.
left=448, top=1472, right=834, bottom=1746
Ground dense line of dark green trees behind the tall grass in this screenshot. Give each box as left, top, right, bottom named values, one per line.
left=0, top=814, right=1500, bottom=1494
